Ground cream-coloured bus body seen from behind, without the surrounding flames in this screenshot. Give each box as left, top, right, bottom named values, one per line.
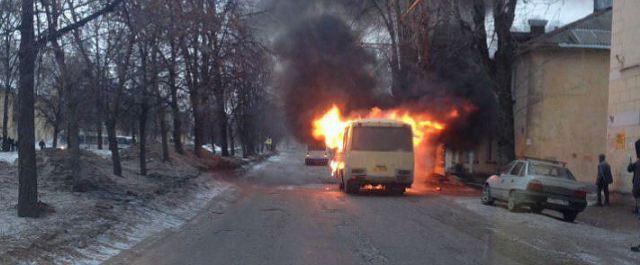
left=334, top=119, right=414, bottom=195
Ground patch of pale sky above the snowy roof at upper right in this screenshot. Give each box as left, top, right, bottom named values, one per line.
left=514, top=0, right=593, bottom=31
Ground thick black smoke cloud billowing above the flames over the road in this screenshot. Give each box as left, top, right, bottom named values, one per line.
left=275, top=14, right=379, bottom=141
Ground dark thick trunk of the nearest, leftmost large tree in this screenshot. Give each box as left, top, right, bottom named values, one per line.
left=18, top=0, right=39, bottom=217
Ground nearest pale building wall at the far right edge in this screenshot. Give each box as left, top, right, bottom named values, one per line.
left=606, top=0, right=640, bottom=191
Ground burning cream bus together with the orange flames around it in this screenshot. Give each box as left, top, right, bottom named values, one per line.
left=312, top=105, right=450, bottom=194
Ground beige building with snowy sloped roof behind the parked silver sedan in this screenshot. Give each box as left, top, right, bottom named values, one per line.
left=513, top=9, right=612, bottom=183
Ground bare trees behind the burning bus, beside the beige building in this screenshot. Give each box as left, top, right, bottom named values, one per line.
left=356, top=0, right=520, bottom=163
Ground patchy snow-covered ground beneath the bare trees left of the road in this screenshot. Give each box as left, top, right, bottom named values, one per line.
left=0, top=145, right=248, bottom=264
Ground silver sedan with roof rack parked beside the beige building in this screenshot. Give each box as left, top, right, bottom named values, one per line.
left=482, top=158, right=587, bottom=222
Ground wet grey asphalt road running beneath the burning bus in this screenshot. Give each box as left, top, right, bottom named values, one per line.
left=107, top=151, right=640, bottom=265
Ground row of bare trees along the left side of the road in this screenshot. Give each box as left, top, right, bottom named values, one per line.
left=0, top=0, right=283, bottom=216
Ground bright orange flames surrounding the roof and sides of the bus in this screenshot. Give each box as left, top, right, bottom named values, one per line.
left=312, top=102, right=460, bottom=174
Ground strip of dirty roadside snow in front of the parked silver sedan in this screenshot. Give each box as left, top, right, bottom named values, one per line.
left=450, top=197, right=640, bottom=264
